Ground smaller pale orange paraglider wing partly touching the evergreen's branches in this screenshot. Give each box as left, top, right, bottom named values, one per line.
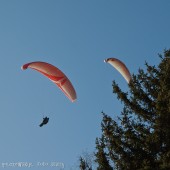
left=104, top=58, right=131, bottom=83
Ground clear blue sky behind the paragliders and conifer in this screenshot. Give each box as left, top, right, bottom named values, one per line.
left=0, top=0, right=170, bottom=170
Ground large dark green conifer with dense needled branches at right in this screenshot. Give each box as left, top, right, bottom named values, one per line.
left=95, top=50, right=170, bottom=170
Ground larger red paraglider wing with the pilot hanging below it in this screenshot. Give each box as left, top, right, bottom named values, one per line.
left=21, top=61, right=77, bottom=102
